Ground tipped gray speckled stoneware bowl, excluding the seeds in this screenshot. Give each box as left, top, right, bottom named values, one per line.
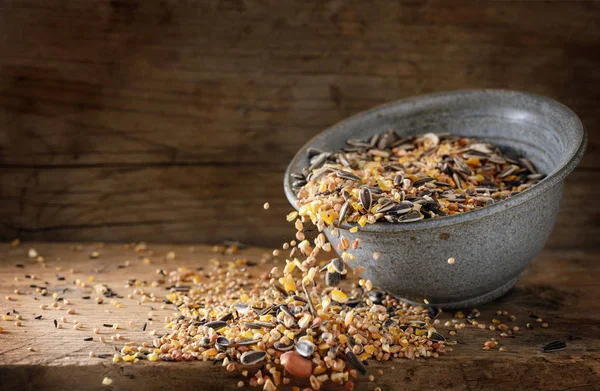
left=284, top=90, right=587, bottom=309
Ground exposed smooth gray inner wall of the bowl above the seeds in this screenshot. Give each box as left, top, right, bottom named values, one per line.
left=284, top=90, right=586, bottom=224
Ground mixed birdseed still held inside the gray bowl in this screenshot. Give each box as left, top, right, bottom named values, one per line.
left=292, top=131, right=544, bottom=230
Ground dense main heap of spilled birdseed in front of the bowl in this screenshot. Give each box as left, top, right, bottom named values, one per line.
left=131, top=253, right=456, bottom=390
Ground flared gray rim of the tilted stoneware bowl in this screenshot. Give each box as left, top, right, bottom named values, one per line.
left=283, top=89, right=588, bottom=232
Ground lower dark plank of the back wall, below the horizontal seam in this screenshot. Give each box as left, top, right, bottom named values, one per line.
left=0, top=165, right=600, bottom=247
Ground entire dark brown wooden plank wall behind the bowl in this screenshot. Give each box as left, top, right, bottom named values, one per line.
left=0, top=0, right=600, bottom=247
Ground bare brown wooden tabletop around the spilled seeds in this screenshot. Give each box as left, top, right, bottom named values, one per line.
left=0, top=243, right=600, bottom=391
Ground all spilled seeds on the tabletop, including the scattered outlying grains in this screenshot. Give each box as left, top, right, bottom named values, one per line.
left=0, top=243, right=567, bottom=390
